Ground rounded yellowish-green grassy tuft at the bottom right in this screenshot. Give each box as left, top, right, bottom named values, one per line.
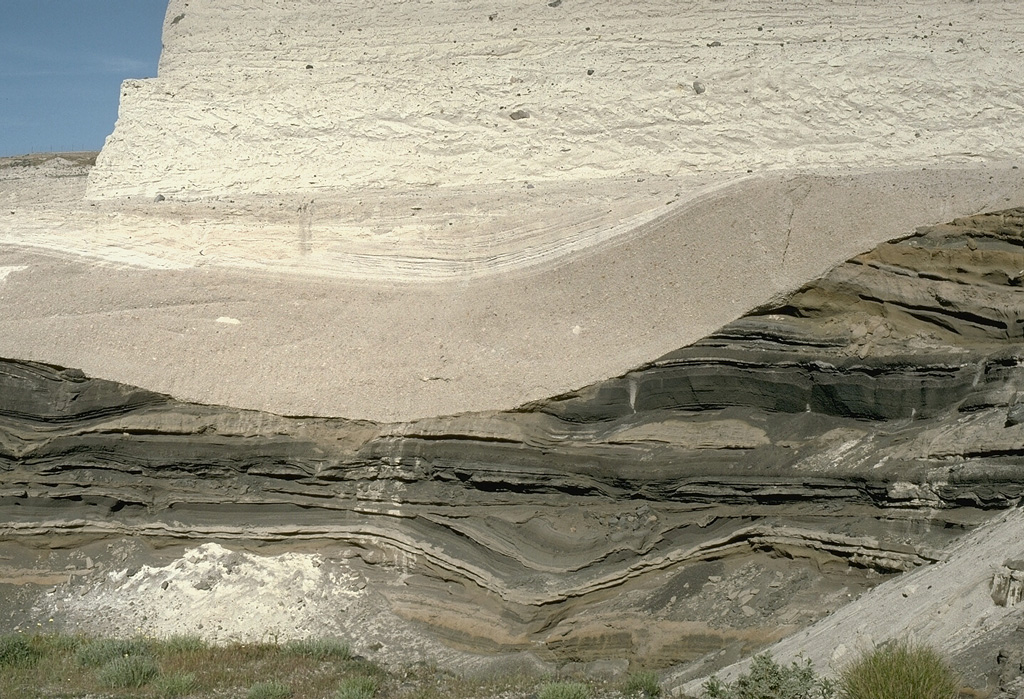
left=839, top=642, right=961, bottom=699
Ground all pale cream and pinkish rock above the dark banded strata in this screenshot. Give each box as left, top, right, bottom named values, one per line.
left=0, top=0, right=1024, bottom=421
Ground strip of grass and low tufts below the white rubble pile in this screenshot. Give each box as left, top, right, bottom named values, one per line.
left=0, top=635, right=544, bottom=699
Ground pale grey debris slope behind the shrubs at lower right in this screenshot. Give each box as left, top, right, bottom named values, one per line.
left=666, top=508, right=1024, bottom=699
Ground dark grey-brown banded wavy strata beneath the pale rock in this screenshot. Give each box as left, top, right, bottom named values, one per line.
left=0, top=209, right=1024, bottom=665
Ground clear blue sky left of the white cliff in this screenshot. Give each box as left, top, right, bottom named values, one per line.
left=0, top=0, right=168, bottom=156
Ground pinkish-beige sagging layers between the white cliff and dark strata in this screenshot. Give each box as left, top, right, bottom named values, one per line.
left=6, top=159, right=1024, bottom=422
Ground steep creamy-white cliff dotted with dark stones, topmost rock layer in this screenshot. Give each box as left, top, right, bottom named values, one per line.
left=89, top=0, right=1024, bottom=199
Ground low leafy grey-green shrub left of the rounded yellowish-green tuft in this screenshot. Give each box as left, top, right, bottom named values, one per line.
left=703, top=653, right=836, bottom=699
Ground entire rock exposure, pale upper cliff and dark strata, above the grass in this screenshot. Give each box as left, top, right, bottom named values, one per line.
left=0, top=0, right=1024, bottom=691
